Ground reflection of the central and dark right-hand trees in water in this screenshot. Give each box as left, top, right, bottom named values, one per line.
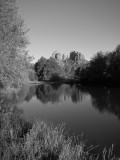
left=36, top=84, right=120, bottom=118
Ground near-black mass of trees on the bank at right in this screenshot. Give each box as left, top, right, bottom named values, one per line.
left=76, top=45, right=120, bottom=85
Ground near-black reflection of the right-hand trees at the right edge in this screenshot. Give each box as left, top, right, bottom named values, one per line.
left=88, top=87, right=120, bottom=118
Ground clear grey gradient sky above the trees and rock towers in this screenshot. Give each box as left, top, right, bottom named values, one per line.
left=17, top=0, right=120, bottom=62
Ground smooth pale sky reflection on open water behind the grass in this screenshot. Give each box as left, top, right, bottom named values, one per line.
left=20, top=85, right=120, bottom=151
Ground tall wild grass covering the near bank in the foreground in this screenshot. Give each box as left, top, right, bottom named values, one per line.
left=0, top=107, right=118, bottom=160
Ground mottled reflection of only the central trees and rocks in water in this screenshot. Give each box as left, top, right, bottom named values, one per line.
left=36, top=84, right=83, bottom=103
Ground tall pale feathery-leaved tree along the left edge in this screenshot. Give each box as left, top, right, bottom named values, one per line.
left=0, top=0, right=32, bottom=88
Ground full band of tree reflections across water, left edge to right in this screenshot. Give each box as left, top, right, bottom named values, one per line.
left=0, top=84, right=120, bottom=119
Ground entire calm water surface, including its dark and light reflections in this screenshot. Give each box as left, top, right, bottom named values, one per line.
left=1, top=84, right=120, bottom=154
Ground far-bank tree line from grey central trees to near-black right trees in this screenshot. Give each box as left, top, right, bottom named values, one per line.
left=35, top=45, right=120, bottom=85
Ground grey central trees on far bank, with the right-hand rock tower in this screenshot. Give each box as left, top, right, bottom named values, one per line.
left=35, top=51, right=86, bottom=82
